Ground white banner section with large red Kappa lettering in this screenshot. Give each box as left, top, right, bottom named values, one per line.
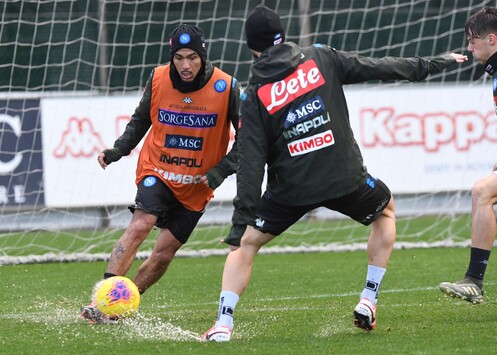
left=344, top=85, right=497, bottom=193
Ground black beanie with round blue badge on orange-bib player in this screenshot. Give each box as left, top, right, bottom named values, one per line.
left=169, top=24, right=207, bottom=63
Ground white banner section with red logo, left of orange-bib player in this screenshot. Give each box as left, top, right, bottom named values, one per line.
left=41, top=95, right=139, bottom=207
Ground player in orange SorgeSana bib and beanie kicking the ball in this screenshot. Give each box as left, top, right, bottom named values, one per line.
left=81, top=24, right=240, bottom=323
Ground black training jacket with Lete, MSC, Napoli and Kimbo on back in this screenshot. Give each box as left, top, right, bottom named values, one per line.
left=226, top=42, right=456, bottom=245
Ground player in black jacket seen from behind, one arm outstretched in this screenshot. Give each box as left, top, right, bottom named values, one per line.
left=203, top=5, right=467, bottom=342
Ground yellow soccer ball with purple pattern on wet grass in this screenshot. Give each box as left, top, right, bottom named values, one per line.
left=94, top=276, right=140, bottom=317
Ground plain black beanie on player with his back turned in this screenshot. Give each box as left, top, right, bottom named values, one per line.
left=245, top=5, right=285, bottom=52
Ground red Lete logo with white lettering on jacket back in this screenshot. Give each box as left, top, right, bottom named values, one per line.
left=257, top=59, right=325, bottom=114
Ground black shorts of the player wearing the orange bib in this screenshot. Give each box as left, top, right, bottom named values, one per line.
left=129, top=176, right=204, bottom=244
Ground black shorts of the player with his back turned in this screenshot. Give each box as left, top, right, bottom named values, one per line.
left=254, top=174, right=392, bottom=235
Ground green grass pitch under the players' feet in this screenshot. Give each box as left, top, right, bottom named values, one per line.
left=0, top=248, right=497, bottom=354
